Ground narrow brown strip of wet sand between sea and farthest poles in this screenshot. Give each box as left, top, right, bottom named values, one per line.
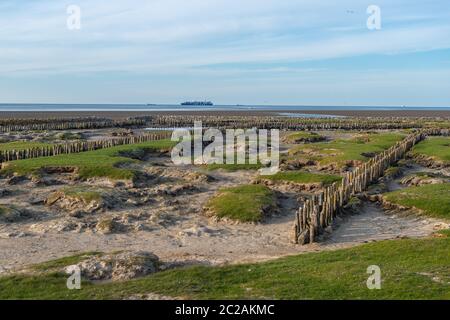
left=0, top=109, right=450, bottom=120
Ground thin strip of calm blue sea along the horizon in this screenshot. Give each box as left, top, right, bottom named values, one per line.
left=0, top=103, right=450, bottom=111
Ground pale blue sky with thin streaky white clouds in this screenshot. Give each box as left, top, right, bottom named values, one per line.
left=0, top=0, right=450, bottom=106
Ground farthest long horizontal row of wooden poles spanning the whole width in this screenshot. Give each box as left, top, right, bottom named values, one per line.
left=0, top=115, right=442, bottom=132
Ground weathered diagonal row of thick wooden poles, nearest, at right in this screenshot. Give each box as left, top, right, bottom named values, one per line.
left=294, top=131, right=430, bottom=244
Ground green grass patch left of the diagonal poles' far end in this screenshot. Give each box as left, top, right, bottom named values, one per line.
left=289, top=133, right=405, bottom=166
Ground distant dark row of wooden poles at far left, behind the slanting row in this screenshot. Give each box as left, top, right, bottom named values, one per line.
left=0, top=117, right=147, bottom=132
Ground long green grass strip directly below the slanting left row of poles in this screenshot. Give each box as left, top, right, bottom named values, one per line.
left=0, top=140, right=175, bottom=180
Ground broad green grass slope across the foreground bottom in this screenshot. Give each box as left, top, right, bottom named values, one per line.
left=0, top=231, right=450, bottom=299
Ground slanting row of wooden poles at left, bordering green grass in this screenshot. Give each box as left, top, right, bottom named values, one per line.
left=0, top=131, right=171, bottom=163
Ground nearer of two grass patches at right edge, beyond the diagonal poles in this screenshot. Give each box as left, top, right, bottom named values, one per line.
left=383, top=183, right=450, bottom=219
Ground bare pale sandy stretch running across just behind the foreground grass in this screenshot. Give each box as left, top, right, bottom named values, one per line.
left=0, top=196, right=442, bottom=272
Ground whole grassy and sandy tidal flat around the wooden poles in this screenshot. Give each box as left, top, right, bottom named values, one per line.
left=0, top=114, right=450, bottom=299
